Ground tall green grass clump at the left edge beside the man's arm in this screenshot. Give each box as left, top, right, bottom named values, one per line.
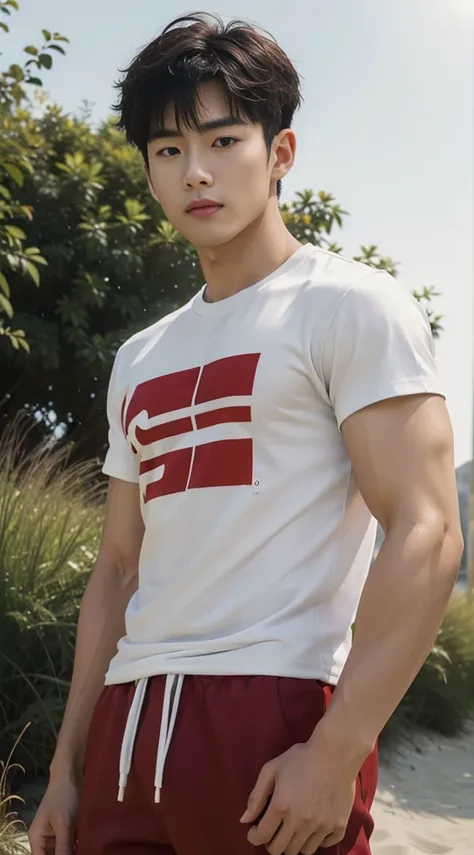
left=0, top=421, right=103, bottom=777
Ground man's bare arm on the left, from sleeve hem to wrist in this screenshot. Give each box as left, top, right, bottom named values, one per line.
left=51, top=478, right=143, bottom=779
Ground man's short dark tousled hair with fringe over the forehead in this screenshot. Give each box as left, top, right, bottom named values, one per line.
left=113, top=13, right=301, bottom=195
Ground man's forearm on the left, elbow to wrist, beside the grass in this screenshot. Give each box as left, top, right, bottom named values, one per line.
left=51, top=566, right=137, bottom=778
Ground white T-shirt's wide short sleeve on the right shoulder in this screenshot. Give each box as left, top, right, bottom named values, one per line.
left=322, top=271, right=444, bottom=429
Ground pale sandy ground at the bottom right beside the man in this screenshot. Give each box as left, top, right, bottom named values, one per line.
left=14, top=727, right=474, bottom=855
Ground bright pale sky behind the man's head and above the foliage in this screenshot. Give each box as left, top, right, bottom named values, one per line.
left=2, top=0, right=474, bottom=464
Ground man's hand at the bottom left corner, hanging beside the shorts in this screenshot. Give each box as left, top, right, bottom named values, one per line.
left=28, top=779, right=79, bottom=855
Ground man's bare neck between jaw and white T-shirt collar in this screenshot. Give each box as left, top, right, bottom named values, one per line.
left=198, top=208, right=300, bottom=303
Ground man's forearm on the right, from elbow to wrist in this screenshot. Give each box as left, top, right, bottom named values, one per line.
left=311, top=526, right=462, bottom=776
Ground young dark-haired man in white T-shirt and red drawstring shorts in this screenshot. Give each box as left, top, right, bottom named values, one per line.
left=31, top=11, right=462, bottom=855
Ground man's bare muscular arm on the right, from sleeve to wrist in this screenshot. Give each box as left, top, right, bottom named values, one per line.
left=312, top=395, right=462, bottom=776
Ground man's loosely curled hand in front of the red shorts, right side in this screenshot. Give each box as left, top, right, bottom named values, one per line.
left=240, top=743, right=355, bottom=855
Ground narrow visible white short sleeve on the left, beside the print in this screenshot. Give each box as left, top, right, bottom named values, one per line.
left=102, top=351, right=139, bottom=483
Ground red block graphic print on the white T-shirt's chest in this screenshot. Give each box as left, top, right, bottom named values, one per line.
left=122, top=353, right=260, bottom=502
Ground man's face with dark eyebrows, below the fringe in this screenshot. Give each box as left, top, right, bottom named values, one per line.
left=148, top=83, right=272, bottom=249
